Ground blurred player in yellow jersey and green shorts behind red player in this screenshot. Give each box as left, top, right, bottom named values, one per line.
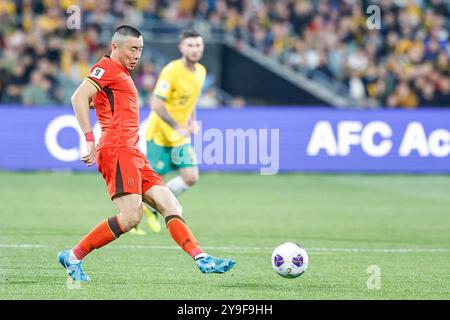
left=130, top=30, right=206, bottom=234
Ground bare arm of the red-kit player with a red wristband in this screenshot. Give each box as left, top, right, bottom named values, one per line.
left=71, top=80, right=98, bottom=166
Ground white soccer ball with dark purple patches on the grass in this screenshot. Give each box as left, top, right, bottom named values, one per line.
left=272, top=242, right=308, bottom=278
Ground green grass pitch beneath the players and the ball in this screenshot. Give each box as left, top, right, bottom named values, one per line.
left=0, top=173, right=450, bottom=300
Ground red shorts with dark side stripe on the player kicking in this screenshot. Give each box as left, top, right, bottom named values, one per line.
left=97, top=148, right=164, bottom=199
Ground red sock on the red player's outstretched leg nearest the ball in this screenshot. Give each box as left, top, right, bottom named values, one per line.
left=166, top=215, right=203, bottom=258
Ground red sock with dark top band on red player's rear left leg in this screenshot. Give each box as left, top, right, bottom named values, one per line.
left=72, top=216, right=124, bottom=260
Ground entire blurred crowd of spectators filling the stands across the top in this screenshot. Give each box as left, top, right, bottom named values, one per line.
left=0, top=0, right=450, bottom=108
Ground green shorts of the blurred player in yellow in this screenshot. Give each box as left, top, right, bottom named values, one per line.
left=147, top=140, right=197, bottom=175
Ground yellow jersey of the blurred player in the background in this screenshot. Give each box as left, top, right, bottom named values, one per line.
left=146, top=59, right=206, bottom=147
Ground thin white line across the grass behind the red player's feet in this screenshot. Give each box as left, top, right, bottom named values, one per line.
left=0, top=243, right=450, bottom=253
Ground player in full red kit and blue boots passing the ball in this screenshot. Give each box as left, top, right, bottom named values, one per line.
left=58, top=25, right=235, bottom=281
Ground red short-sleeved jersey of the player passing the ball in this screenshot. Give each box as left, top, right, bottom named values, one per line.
left=86, top=56, right=139, bottom=150
